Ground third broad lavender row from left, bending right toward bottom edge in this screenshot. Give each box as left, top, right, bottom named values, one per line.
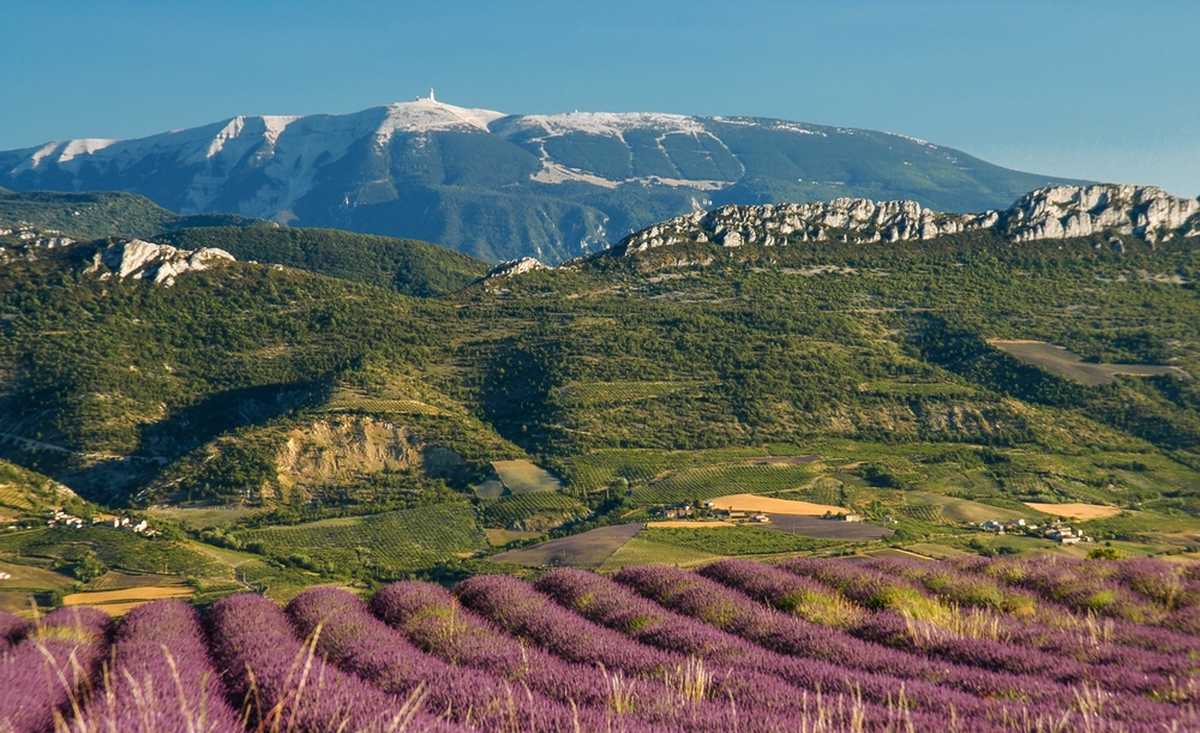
left=209, top=594, right=462, bottom=733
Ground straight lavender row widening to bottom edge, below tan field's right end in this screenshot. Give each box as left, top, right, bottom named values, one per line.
left=70, top=600, right=245, bottom=733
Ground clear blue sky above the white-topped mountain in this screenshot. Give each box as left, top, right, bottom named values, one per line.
left=0, top=0, right=1200, bottom=196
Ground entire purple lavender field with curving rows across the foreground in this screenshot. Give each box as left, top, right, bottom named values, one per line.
left=0, top=558, right=1200, bottom=733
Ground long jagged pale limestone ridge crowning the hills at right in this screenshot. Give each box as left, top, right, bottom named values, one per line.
left=613, top=185, right=1200, bottom=254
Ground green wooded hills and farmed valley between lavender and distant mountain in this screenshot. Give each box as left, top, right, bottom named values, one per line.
left=0, top=183, right=1200, bottom=609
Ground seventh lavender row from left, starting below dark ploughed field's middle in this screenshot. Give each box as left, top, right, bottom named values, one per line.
left=536, top=569, right=986, bottom=729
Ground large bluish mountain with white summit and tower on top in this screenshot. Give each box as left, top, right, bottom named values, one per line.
left=0, top=94, right=1089, bottom=262
